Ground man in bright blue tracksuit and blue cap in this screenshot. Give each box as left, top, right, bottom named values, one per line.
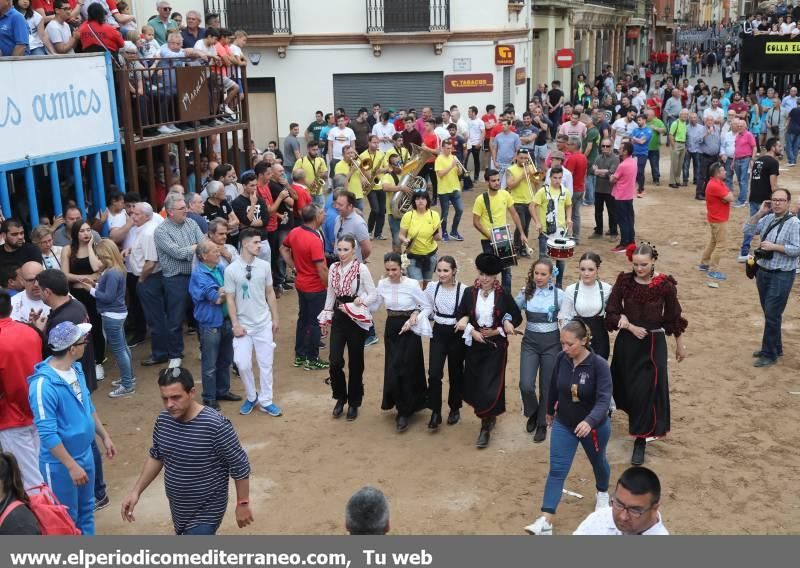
left=28, top=322, right=116, bottom=535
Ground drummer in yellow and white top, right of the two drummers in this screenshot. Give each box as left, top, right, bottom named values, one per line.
left=532, top=166, right=575, bottom=288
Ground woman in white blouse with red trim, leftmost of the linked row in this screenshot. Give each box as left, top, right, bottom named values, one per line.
left=318, top=235, right=377, bottom=420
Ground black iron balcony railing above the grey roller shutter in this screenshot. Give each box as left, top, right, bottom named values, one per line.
left=367, top=0, right=450, bottom=33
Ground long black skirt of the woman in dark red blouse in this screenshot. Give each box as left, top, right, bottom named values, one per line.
left=611, top=330, right=670, bottom=438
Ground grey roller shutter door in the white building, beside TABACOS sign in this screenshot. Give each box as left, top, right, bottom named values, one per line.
left=333, top=72, right=444, bottom=116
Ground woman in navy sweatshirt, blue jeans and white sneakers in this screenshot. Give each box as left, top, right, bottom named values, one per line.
left=525, top=320, right=611, bottom=535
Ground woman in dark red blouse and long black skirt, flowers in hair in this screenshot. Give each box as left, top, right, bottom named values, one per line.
left=606, top=244, right=688, bottom=465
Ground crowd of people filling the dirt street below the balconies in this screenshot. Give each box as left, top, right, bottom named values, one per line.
left=0, top=23, right=800, bottom=535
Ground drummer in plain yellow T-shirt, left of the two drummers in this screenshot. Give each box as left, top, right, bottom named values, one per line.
left=472, top=168, right=528, bottom=296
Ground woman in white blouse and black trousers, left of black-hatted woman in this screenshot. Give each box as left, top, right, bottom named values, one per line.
left=419, top=256, right=467, bottom=430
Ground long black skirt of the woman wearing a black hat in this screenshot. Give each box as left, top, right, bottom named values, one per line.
left=464, top=335, right=508, bottom=418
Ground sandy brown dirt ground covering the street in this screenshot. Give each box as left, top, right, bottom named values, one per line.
left=94, top=156, right=800, bottom=535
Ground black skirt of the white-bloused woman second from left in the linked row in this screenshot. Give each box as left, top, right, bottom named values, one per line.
left=381, top=316, right=427, bottom=416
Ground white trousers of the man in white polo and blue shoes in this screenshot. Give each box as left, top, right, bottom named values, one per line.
left=233, top=322, right=275, bottom=406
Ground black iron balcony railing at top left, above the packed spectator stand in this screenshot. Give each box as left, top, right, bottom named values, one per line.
left=204, top=0, right=292, bottom=35
